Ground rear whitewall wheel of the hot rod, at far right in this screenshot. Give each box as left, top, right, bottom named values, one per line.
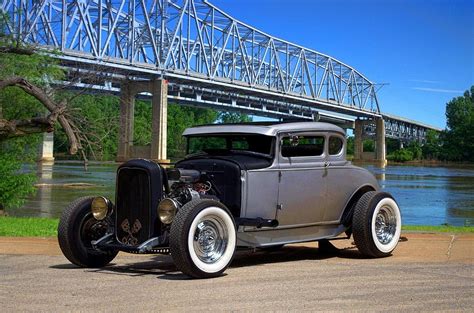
left=352, top=191, right=402, bottom=257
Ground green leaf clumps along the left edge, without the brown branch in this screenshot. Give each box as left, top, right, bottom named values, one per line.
left=0, top=42, right=63, bottom=209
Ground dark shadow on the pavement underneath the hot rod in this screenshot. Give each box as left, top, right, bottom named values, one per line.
left=50, top=239, right=372, bottom=280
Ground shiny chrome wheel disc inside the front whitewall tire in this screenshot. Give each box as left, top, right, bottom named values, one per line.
left=193, top=215, right=229, bottom=264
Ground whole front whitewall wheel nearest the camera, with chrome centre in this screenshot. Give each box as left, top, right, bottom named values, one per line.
left=170, top=200, right=236, bottom=278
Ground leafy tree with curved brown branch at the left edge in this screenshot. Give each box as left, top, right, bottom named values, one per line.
left=0, top=20, right=81, bottom=154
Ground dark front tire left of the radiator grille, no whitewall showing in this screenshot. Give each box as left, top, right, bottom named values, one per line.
left=58, top=197, right=118, bottom=267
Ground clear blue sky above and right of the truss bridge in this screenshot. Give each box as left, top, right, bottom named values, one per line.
left=210, top=0, right=474, bottom=128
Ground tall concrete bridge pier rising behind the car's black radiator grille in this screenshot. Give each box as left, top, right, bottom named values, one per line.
left=116, top=79, right=168, bottom=162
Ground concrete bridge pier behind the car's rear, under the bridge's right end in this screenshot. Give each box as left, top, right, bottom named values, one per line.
left=354, top=118, right=387, bottom=167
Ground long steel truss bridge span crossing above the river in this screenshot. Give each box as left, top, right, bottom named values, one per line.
left=0, top=0, right=440, bottom=140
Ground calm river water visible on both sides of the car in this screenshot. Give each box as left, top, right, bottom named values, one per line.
left=8, top=161, right=474, bottom=226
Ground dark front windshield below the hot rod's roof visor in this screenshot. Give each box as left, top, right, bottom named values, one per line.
left=187, top=134, right=273, bottom=156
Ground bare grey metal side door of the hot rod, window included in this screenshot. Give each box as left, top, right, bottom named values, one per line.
left=277, top=133, right=326, bottom=228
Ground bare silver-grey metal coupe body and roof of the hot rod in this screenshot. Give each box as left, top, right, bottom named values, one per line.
left=183, top=122, right=380, bottom=247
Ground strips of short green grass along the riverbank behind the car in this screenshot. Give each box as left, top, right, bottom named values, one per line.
left=0, top=216, right=474, bottom=237
